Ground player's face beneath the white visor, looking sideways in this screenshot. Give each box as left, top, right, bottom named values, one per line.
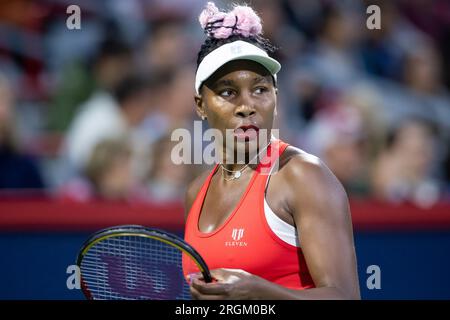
left=195, top=60, right=277, bottom=155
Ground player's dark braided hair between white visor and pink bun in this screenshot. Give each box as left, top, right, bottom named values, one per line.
left=197, top=35, right=278, bottom=69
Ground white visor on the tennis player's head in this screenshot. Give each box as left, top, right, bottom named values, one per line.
left=195, top=40, right=281, bottom=94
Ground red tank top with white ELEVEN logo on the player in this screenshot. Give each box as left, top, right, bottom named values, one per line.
left=183, top=140, right=314, bottom=289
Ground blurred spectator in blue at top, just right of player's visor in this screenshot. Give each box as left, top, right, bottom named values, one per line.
left=280, top=0, right=367, bottom=130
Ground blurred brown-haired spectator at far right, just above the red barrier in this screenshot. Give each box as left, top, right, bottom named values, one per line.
left=372, top=118, right=440, bottom=207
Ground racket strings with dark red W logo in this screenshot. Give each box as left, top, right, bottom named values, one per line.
left=80, top=236, right=191, bottom=300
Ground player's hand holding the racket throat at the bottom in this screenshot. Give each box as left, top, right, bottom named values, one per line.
left=190, top=269, right=264, bottom=300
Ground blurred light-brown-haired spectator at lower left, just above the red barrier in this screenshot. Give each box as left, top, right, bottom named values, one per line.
left=59, top=138, right=139, bottom=202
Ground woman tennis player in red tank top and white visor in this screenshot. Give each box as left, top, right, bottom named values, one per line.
left=183, top=2, right=360, bottom=299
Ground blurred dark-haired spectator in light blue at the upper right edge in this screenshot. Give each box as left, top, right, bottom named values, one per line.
left=377, top=40, right=450, bottom=174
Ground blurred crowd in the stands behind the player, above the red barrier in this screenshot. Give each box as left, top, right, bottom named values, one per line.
left=0, top=0, right=450, bottom=207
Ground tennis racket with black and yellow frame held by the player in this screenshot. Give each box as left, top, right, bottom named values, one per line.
left=77, top=225, right=211, bottom=300
